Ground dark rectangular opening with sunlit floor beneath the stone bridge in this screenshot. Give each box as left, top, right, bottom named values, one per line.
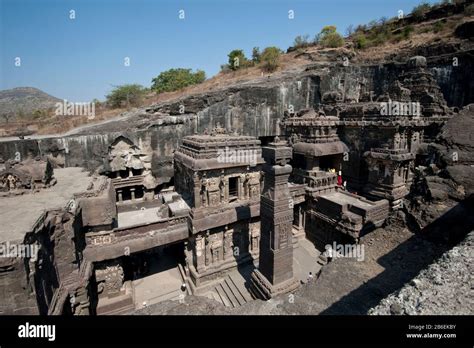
left=124, top=242, right=186, bottom=309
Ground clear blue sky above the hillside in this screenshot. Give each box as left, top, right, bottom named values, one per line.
left=0, top=0, right=435, bottom=102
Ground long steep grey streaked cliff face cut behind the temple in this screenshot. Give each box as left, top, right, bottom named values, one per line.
left=0, top=40, right=474, bottom=180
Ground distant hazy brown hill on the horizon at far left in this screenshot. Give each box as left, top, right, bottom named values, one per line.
left=0, top=87, right=61, bottom=122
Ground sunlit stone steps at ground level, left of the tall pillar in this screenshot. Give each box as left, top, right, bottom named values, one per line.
left=206, top=275, right=252, bottom=308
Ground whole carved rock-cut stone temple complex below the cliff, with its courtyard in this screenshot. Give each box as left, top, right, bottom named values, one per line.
left=0, top=51, right=468, bottom=315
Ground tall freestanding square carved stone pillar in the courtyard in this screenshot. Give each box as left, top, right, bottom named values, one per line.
left=252, top=138, right=298, bottom=299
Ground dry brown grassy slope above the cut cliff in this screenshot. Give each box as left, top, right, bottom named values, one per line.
left=0, top=1, right=474, bottom=136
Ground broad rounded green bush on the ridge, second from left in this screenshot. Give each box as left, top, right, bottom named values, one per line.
left=151, top=68, right=206, bottom=93
